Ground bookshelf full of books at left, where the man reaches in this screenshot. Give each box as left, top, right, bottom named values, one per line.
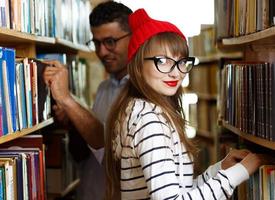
left=0, top=0, right=95, bottom=200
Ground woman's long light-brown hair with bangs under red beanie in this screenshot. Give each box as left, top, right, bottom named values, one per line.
left=105, top=32, right=196, bottom=199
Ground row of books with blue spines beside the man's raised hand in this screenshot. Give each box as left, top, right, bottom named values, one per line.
left=0, top=48, right=51, bottom=135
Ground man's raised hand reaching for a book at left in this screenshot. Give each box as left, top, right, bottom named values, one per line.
left=44, top=61, right=72, bottom=105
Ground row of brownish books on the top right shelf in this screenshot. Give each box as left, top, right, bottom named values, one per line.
left=215, top=0, right=275, bottom=38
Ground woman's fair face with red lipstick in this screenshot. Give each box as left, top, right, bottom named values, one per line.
left=142, top=47, right=188, bottom=96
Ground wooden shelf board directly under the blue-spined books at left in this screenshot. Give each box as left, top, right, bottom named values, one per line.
left=0, top=118, right=53, bottom=144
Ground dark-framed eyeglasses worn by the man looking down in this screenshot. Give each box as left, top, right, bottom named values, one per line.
left=86, top=33, right=131, bottom=51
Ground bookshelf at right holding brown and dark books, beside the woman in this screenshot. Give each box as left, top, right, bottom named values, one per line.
left=215, top=0, right=275, bottom=200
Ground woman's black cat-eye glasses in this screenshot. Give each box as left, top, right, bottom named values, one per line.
left=144, top=56, right=196, bottom=74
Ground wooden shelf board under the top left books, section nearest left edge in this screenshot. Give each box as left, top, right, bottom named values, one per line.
left=0, top=28, right=55, bottom=45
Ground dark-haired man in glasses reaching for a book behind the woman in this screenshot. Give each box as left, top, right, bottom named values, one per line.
left=44, top=1, right=132, bottom=200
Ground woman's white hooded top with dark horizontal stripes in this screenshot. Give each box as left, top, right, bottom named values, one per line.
left=113, top=99, right=251, bottom=200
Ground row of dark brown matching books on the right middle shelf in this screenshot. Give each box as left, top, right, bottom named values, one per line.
left=220, top=62, right=275, bottom=141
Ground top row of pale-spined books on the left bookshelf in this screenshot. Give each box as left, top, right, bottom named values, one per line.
left=0, top=0, right=91, bottom=44
